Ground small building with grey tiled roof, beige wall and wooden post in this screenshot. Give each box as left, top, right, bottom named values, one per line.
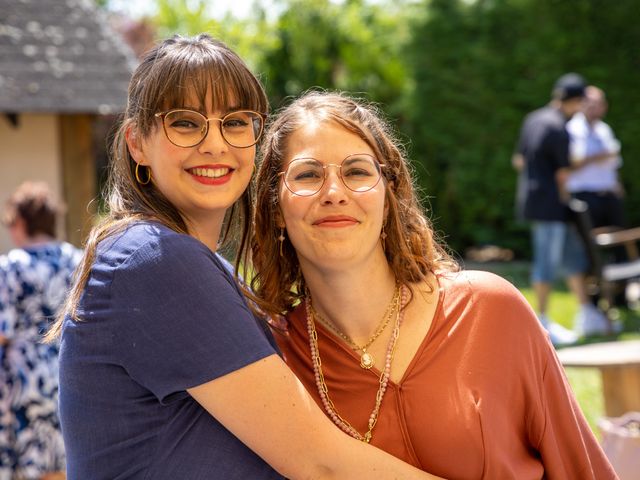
left=0, top=0, right=136, bottom=252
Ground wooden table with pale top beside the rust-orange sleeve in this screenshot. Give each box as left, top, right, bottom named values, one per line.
left=557, top=340, right=640, bottom=417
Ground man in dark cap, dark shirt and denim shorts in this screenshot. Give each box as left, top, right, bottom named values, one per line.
left=513, top=73, right=608, bottom=345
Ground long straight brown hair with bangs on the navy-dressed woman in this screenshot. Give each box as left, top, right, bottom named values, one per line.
left=47, top=34, right=268, bottom=340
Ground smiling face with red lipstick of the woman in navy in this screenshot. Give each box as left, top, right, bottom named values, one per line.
left=129, top=94, right=255, bottom=235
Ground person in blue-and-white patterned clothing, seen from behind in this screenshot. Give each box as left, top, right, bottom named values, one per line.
left=0, top=182, right=81, bottom=480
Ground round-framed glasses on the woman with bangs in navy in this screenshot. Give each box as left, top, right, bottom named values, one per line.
left=155, top=109, right=264, bottom=148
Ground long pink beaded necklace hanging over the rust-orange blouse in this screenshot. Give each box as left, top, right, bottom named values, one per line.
left=305, top=286, right=407, bottom=443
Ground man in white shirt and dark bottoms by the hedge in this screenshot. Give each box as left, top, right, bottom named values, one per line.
left=567, top=86, right=624, bottom=228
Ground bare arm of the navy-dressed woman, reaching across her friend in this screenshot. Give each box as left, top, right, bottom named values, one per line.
left=188, top=355, right=441, bottom=480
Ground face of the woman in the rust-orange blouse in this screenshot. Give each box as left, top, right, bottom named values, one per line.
left=279, top=121, right=385, bottom=270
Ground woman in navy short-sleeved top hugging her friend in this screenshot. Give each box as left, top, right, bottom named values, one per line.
left=49, top=35, right=442, bottom=480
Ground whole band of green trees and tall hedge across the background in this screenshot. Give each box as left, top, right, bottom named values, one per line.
left=102, top=0, right=640, bottom=255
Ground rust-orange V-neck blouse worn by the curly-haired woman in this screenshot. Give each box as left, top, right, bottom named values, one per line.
left=276, top=271, right=617, bottom=480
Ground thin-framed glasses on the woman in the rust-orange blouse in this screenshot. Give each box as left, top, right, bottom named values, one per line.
left=279, top=153, right=384, bottom=197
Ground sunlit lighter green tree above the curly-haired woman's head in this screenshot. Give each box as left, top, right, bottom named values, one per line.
left=259, top=0, right=410, bottom=108
